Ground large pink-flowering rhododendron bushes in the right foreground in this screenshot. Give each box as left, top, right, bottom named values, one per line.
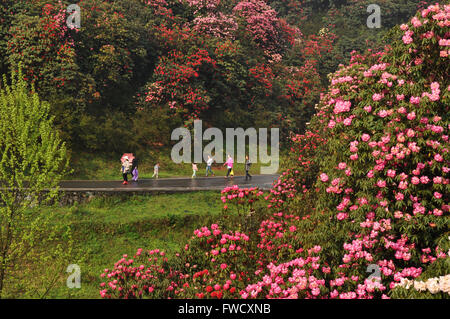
left=100, top=4, right=450, bottom=299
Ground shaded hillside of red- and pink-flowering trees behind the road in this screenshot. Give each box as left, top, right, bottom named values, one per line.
left=0, top=0, right=431, bottom=162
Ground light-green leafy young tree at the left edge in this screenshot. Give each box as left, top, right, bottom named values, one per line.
left=0, top=68, right=71, bottom=297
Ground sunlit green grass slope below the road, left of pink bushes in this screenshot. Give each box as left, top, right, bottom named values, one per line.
left=33, top=192, right=222, bottom=298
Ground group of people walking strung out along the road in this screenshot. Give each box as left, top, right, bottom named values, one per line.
left=121, top=154, right=252, bottom=185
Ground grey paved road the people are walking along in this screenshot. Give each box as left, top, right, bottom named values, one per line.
left=60, top=175, right=278, bottom=192
